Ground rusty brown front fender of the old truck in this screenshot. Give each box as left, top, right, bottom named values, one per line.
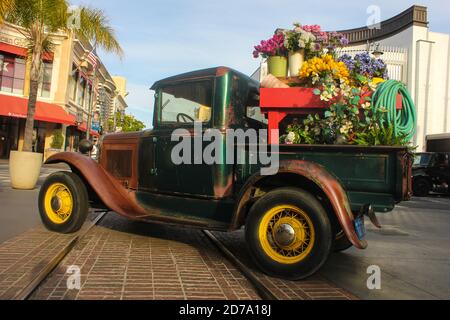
left=46, top=152, right=148, bottom=218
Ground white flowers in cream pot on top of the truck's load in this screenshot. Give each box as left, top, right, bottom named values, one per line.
left=283, top=23, right=316, bottom=77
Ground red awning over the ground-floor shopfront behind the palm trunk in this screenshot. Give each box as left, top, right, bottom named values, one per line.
left=0, top=94, right=75, bottom=125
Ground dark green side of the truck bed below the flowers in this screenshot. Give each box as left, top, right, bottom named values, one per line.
left=243, top=145, right=412, bottom=212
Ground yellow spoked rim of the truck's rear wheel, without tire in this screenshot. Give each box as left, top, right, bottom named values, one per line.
left=258, top=205, right=315, bottom=264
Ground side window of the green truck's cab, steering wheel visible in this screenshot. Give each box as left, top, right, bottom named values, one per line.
left=159, top=80, right=212, bottom=124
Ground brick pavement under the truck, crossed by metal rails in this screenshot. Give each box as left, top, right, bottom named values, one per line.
left=0, top=213, right=354, bottom=300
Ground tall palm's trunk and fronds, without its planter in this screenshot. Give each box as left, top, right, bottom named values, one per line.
left=0, top=0, right=123, bottom=152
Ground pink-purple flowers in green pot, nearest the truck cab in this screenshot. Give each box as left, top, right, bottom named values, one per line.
left=253, top=33, right=288, bottom=77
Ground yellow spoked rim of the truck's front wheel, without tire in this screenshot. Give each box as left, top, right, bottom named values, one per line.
left=44, top=183, right=73, bottom=224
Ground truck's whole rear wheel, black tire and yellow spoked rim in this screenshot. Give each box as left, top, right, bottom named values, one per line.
left=246, top=188, right=334, bottom=280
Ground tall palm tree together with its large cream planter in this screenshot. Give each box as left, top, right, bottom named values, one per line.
left=0, top=0, right=122, bottom=189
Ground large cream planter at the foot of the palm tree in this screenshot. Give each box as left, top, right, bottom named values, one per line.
left=9, top=151, right=42, bottom=190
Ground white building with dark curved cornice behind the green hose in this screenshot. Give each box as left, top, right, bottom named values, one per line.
left=253, top=6, right=450, bottom=152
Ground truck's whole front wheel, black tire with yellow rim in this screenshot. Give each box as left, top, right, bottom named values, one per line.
left=39, top=172, right=89, bottom=233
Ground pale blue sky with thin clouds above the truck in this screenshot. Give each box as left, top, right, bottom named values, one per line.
left=69, top=0, right=450, bottom=127
